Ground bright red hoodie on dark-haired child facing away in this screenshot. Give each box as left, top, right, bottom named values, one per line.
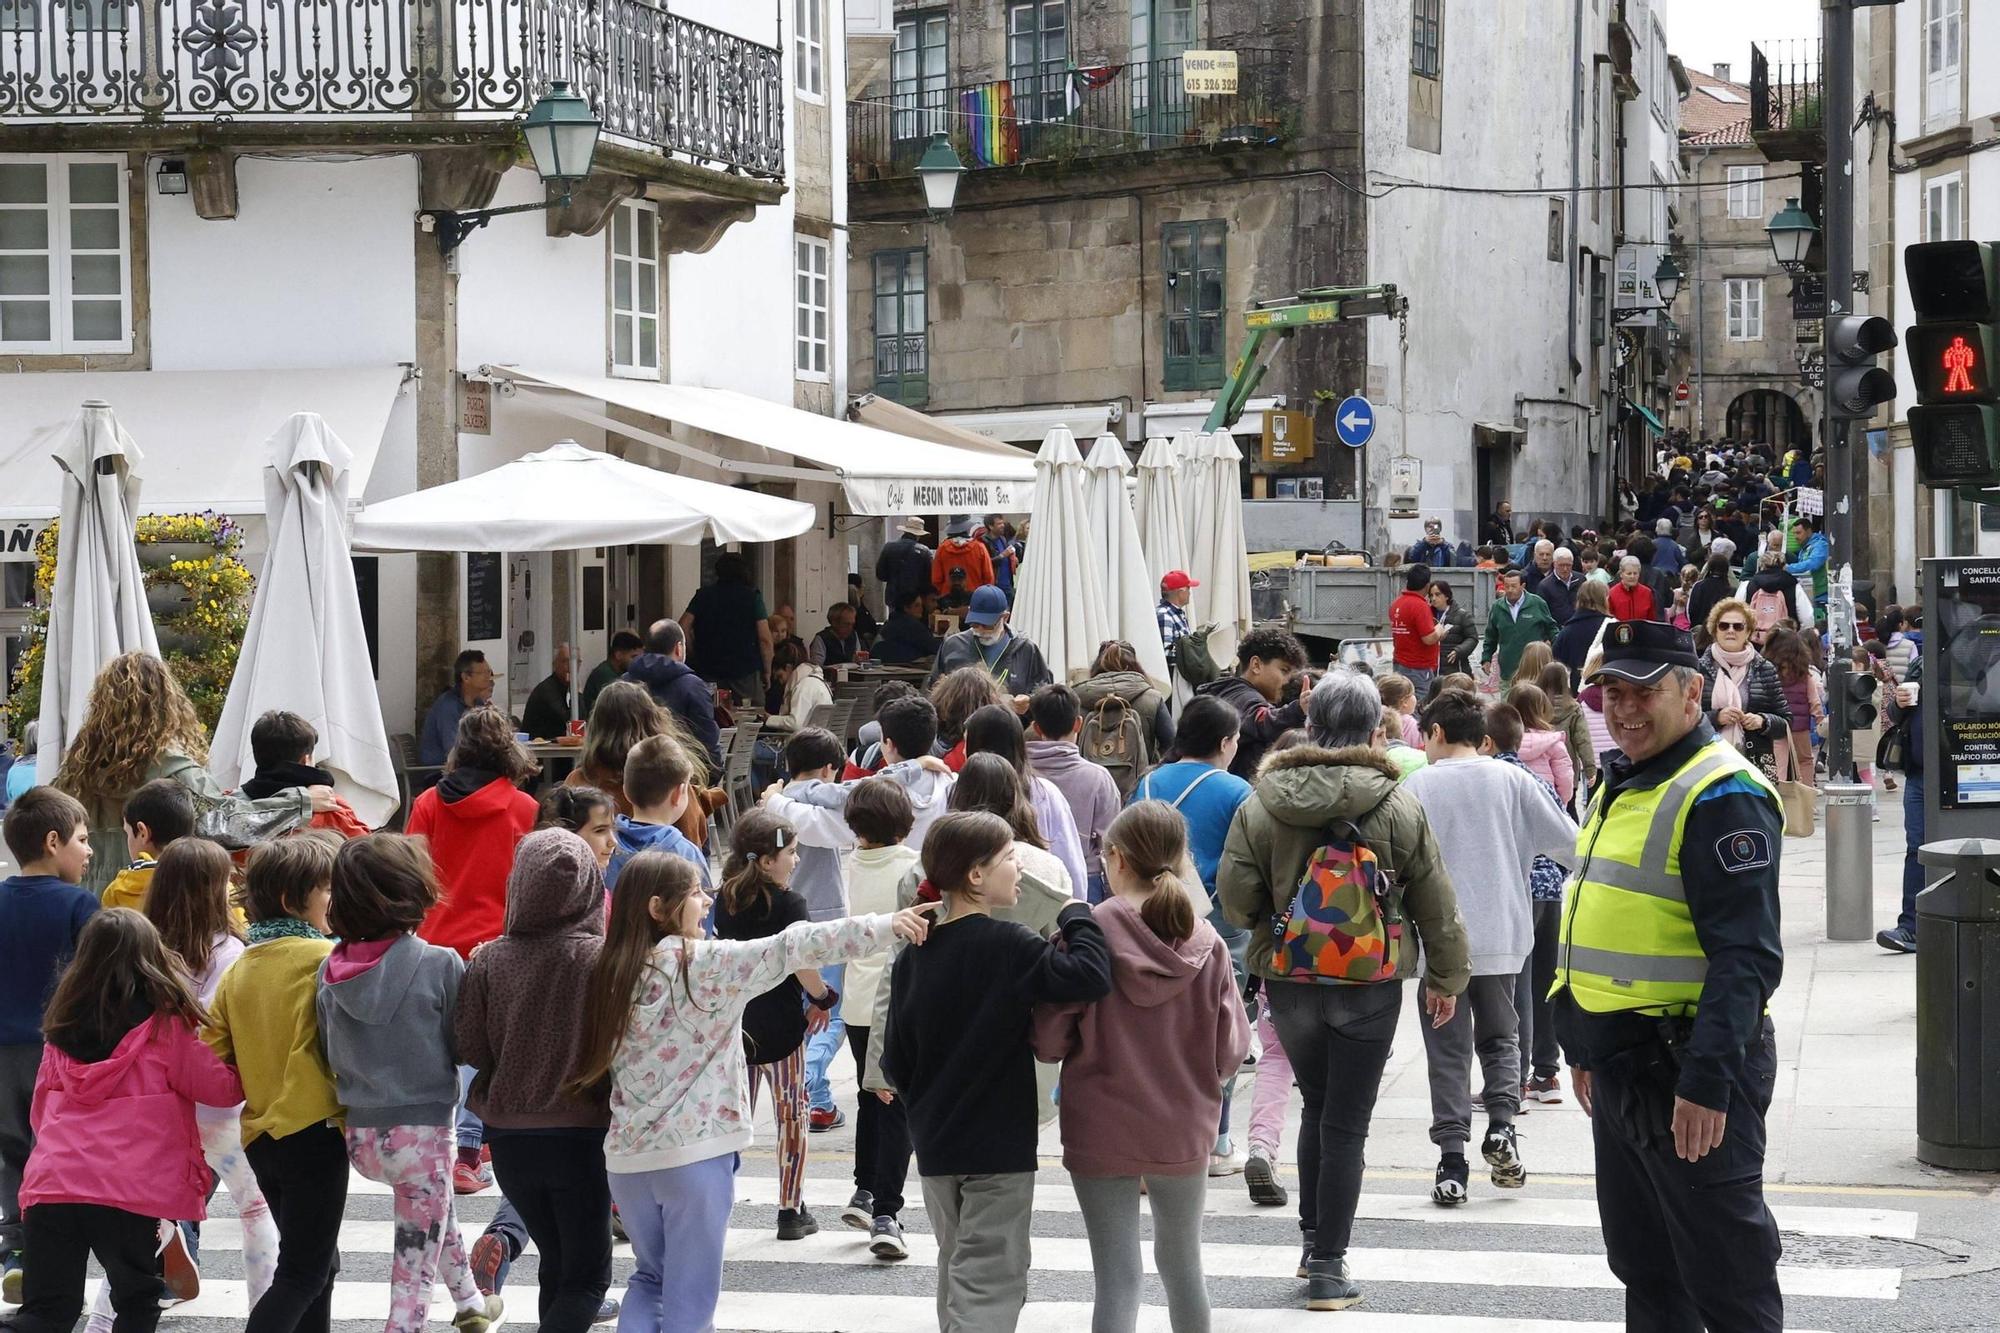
left=404, top=773, right=536, bottom=959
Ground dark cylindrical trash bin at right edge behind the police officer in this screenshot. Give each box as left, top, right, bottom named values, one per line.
left=1916, top=839, right=2000, bottom=1171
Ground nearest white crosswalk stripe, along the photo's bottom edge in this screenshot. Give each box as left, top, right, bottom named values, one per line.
left=162, top=1281, right=1840, bottom=1333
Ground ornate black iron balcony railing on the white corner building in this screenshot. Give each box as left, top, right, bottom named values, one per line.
left=0, top=0, right=784, bottom=178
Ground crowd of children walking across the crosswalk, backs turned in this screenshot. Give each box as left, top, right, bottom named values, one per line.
left=0, top=632, right=1648, bottom=1333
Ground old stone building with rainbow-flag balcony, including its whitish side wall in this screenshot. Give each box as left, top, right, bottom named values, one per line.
left=848, top=0, right=1674, bottom=550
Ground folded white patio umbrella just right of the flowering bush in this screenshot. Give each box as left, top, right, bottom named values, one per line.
left=210, top=412, right=400, bottom=829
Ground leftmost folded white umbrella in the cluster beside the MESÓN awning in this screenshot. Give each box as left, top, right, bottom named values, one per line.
left=1012, top=426, right=1114, bottom=683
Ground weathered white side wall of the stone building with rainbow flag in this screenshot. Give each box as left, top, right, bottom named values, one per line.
left=1364, top=0, right=1602, bottom=544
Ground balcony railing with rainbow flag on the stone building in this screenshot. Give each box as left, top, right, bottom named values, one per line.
left=848, top=48, right=1298, bottom=180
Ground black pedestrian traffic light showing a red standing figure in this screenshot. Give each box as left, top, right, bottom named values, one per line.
left=1902, top=240, right=2000, bottom=488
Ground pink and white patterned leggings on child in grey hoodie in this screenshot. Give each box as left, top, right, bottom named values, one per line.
left=348, top=1125, right=482, bottom=1333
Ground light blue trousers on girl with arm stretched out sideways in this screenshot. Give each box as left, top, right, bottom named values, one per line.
left=610, top=1153, right=740, bottom=1333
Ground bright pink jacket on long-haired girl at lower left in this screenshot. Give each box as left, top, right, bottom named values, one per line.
left=20, top=1015, right=244, bottom=1221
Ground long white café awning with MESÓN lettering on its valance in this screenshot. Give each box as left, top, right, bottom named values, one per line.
left=482, top=366, right=1034, bottom=516
